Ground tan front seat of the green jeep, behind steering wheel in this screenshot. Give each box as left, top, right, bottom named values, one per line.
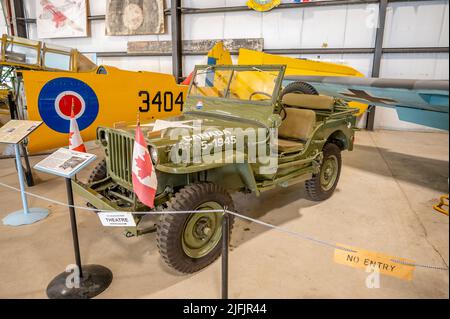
left=278, top=108, right=316, bottom=153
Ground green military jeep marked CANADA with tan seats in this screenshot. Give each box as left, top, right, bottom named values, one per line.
left=73, top=65, right=357, bottom=273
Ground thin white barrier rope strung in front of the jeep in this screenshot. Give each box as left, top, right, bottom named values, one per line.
left=0, top=182, right=449, bottom=271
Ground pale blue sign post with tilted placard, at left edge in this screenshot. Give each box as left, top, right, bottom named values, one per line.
left=0, top=120, right=49, bottom=226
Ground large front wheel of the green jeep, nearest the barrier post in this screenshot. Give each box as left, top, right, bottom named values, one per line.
left=157, top=183, right=234, bottom=273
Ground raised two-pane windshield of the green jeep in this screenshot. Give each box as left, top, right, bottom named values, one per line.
left=189, top=65, right=282, bottom=104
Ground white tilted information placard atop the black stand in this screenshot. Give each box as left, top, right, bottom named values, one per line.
left=34, top=148, right=97, bottom=178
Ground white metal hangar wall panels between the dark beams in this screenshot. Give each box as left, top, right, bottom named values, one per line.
left=8, top=0, right=449, bottom=129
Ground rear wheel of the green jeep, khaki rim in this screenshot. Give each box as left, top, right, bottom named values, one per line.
left=305, top=143, right=342, bottom=201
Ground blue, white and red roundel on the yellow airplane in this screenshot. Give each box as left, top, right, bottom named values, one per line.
left=38, top=78, right=99, bottom=133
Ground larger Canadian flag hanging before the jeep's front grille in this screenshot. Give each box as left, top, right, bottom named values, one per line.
left=132, top=122, right=158, bottom=208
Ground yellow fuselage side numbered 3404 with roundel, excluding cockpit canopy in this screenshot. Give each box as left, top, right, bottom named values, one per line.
left=22, top=66, right=187, bottom=153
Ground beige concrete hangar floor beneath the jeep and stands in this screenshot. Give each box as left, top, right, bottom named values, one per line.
left=0, top=131, right=449, bottom=298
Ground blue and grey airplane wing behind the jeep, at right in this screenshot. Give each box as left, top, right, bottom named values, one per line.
left=285, top=76, right=449, bottom=131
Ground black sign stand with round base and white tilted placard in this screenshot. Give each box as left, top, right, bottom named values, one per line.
left=34, top=149, right=113, bottom=299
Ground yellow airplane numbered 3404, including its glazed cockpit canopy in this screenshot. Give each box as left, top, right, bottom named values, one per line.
left=0, top=34, right=187, bottom=153
